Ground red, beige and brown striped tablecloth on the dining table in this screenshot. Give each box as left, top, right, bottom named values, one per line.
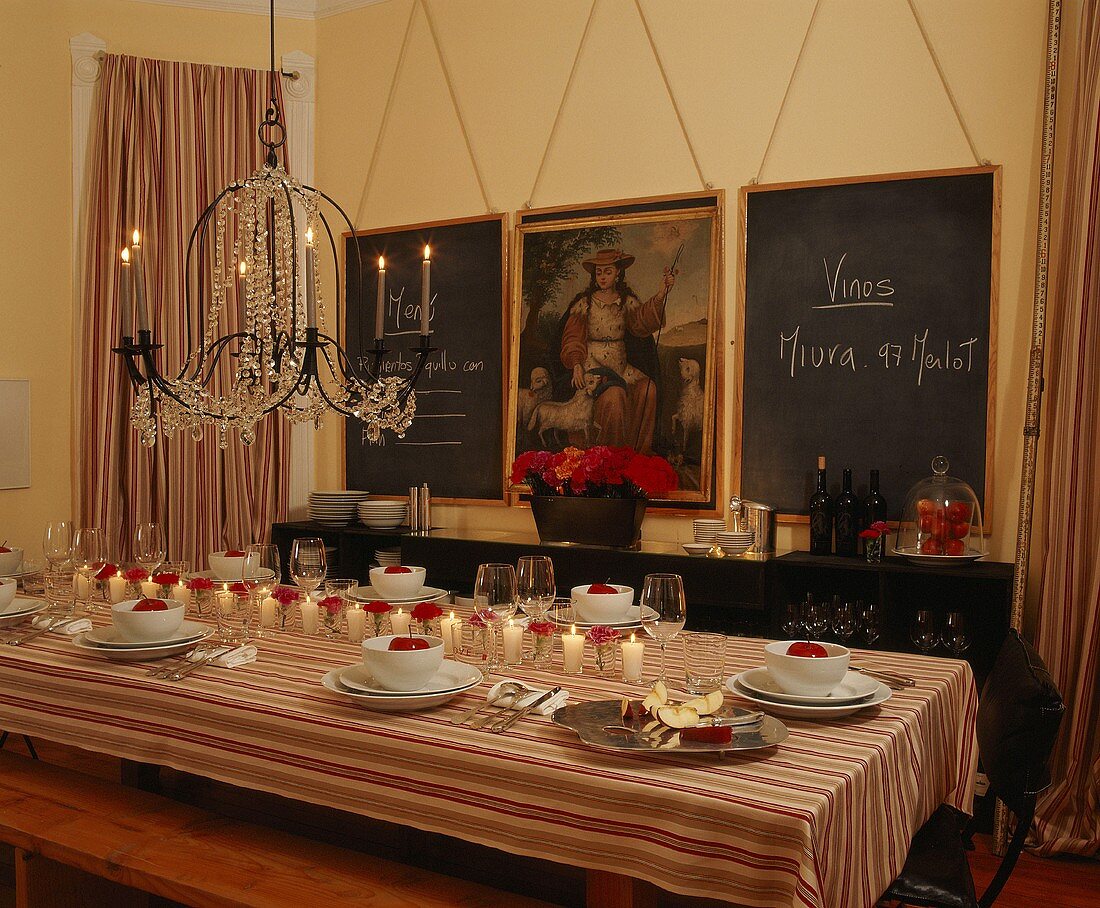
left=0, top=607, right=977, bottom=908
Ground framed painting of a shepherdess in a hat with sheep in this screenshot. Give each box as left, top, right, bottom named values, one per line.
left=506, top=192, right=723, bottom=510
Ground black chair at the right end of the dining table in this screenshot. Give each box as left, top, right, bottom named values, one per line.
left=882, top=631, right=1066, bottom=908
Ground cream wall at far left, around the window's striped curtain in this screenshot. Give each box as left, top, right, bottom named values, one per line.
left=0, top=0, right=315, bottom=557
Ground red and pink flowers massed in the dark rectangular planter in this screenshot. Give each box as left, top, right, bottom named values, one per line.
left=512, top=445, right=679, bottom=499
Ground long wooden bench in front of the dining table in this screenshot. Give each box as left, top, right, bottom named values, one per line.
left=0, top=753, right=547, bottom=908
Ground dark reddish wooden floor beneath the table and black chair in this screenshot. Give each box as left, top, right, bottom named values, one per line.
left=0, top=736, right=1100, bottom=908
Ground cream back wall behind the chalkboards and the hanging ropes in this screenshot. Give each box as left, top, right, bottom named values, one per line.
left=316, top=0, right=1046, bottom=560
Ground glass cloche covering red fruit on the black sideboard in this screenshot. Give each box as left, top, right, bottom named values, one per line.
left=894, top=457, right=986, bottom=566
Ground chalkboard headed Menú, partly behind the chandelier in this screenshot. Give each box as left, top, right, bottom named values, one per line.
left=344, top=215, right=507, bottom=502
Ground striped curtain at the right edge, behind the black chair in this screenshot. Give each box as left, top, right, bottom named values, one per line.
left=1034, top=3, right=1100, bottom=855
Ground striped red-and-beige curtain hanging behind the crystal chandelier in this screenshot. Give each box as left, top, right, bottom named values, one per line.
left=73, top=55, right=290, bottom=570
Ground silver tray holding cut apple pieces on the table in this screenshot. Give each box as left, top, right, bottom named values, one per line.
left=553, top=700, right=789, bottom=754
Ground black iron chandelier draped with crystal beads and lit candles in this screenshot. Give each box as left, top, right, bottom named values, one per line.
left=113, top=0, right=435, bottom=448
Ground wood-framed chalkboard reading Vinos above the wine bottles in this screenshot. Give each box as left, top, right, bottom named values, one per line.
left=734, top=166, right=1001, bottom=527
